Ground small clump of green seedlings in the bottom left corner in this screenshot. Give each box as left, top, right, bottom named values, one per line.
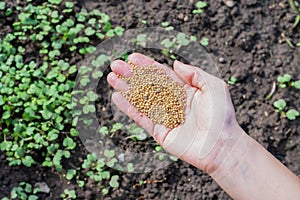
left=1, top=182, right=40, bottom=200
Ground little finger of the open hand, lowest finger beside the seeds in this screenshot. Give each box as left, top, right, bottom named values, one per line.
left=112, top=92, right=154, bottom=136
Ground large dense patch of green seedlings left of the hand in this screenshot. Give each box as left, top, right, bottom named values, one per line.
left=0, top=0, right=124, bottom=175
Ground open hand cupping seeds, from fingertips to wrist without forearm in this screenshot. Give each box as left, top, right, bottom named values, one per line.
left=107, top=53, right=237, bottom=171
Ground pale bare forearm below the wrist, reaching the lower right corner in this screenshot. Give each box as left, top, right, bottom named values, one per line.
left=209, top=124, right=300, bottom=199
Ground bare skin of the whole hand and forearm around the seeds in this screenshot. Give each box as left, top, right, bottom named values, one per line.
left=107, top=53, right=300, bottom=199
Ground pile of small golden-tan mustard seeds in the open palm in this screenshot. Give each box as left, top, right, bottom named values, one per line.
left=119, top=62, right=186, bottom=129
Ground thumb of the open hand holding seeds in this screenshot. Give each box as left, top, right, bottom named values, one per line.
left=173, top=60, right=208, bottom=89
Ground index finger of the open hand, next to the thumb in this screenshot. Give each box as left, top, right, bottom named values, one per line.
left=128, top=53, right=184, bottom=84
